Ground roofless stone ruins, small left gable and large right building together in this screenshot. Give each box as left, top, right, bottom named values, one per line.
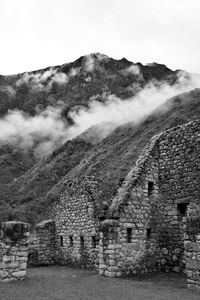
left=27, top=120, right=200, bottom=290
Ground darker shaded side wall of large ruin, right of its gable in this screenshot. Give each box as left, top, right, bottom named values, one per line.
left=159, top=121, right=200, bottom=272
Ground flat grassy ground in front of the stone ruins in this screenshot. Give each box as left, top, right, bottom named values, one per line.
left=0, top=266, right=200, bottom=300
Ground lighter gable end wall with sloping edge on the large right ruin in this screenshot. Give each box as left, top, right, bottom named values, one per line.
left=99, top=136, right=160, bottom=277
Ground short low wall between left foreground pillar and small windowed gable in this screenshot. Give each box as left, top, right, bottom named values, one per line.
left=28, top=220, right=55, bottom=266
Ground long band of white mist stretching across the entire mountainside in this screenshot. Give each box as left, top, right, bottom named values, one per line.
left=0, top=73, right=200, bottom=157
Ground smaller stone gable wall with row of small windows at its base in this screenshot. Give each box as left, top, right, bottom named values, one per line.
left=54, top=178, right=99, bottom=268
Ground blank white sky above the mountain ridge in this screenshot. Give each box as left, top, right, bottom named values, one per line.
left=0, top=0, right=200, bottom=74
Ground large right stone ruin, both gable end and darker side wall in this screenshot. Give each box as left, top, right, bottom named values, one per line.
left=100, top=121, right=200, bottom=276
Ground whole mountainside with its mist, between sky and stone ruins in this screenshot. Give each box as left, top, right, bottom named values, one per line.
left=0, top=53, right=200, bottom=223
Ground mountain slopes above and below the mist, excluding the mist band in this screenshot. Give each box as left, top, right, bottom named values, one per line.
left=0, top=53, right=200, bottom=224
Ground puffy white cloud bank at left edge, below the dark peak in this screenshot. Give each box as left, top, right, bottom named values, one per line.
left=0, top=107, right=69, bottom=156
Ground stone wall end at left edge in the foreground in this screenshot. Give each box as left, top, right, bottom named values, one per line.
left=0, top=221, right=29, bottom=282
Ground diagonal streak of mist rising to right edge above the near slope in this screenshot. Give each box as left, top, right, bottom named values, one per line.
left=69, top=73, right=200, bottom=137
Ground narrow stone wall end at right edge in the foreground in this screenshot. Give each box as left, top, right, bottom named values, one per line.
left=184, top=204, right=200, bottom=292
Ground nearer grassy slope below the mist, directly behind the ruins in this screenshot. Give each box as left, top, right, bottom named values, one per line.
left=0, top=89, right=200, bottom=223
